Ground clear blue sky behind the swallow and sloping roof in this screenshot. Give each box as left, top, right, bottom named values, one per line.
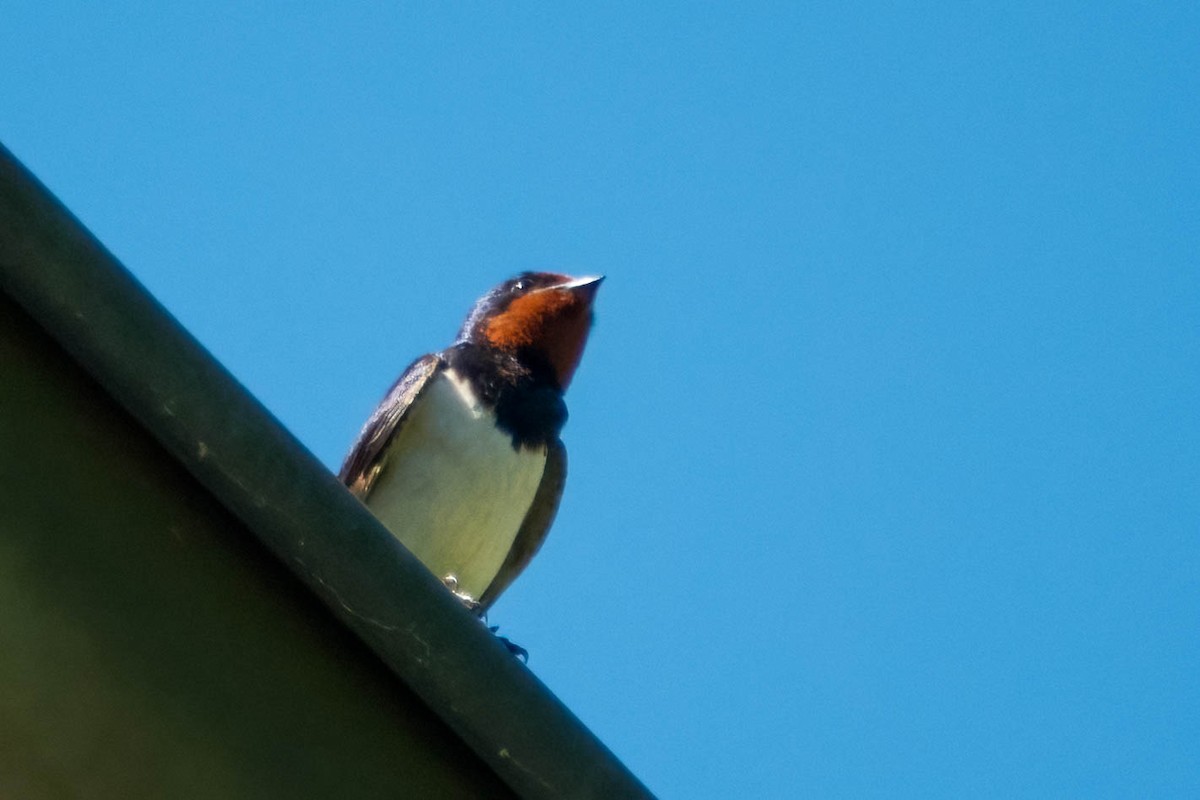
left=0, top=1, right=1200, bottom=798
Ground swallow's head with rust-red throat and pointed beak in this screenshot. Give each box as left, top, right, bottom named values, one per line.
left=458, top=272, right=604, bottom=390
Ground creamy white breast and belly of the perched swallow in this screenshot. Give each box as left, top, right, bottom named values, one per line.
left=366, top=369, right=546, bottom=599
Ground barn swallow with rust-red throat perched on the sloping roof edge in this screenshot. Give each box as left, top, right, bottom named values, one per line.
left=338, top=272, right=604, bottom=615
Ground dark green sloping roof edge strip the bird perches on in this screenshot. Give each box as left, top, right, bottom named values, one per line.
left=0, top=145, right=650, bottom=798
